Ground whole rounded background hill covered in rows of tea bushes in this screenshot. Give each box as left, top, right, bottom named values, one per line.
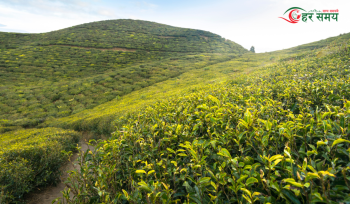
left=0, top=20, right=247, bottom=132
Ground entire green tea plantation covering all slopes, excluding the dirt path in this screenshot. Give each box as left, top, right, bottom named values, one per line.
left=0, top=20, right=350, bottom=204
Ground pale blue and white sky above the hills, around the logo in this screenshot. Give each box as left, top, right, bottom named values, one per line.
left=0, top=0, right=350, bottom=53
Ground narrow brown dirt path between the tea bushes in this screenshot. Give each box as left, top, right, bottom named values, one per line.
left=26, top=141, right=93, bottom=204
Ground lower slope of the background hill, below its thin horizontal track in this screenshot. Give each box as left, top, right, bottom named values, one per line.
left=0, top=47, right=236, bottom=127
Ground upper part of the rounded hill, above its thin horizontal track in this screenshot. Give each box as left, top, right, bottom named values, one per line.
left=0, top=20, right=246, bottom=54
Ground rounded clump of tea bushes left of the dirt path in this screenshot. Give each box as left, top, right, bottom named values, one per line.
left=0, top=128, right=80, bottom=203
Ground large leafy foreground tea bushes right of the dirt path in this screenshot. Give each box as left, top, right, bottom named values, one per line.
left=57, top=42, right=350, bottom=203
